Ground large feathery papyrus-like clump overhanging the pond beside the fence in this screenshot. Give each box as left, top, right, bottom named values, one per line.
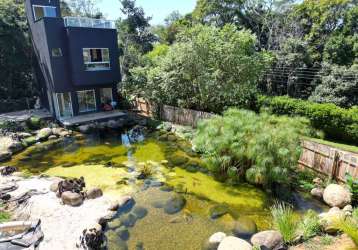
left=193, top=109, right=312, bottom=187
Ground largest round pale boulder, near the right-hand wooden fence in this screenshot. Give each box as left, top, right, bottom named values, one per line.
left=323, top=184, right=352, bottom=208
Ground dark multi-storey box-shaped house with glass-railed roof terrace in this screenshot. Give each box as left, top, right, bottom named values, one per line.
left=25, top=0, right=121, bottom=120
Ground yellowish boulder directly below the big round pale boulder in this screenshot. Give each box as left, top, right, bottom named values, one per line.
left=319, top=207, right=346, bottom=234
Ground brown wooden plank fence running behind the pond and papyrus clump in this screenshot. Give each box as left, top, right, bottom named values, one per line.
left=135, top=99, right=358, bottom=182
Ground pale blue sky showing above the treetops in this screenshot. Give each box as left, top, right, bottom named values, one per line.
left=98, top=0, right=196, bottom=24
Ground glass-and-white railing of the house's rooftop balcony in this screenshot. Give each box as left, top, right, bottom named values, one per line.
left=63, top=17, right=116, bottom=29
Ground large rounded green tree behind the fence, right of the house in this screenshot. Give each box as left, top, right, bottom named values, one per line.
left=131, top=25, right=269, bottom=112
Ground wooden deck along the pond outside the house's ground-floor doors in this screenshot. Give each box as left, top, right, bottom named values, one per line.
left=60, top=110, right=127, bottom=127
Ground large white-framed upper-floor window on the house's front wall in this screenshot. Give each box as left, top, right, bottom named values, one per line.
left=83, top=48, right=111, bottom=71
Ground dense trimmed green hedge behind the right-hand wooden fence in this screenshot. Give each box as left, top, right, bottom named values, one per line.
left=259, top=96, right=358, bottom=145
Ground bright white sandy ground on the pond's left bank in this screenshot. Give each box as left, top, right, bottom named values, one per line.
left=0, top=177, right=112, bottom=250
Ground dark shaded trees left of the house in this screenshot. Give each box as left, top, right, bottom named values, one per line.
left=0, top=0, right=35, bottom=99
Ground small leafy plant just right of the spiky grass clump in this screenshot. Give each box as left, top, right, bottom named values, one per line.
left=298, top=210, right=321, bottom=240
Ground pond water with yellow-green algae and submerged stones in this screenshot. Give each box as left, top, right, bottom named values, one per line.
left=7, top=132, right=271, bottom=250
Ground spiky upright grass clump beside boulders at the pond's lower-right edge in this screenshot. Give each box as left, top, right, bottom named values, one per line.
left=271, top=202, right=298, bottom=244
